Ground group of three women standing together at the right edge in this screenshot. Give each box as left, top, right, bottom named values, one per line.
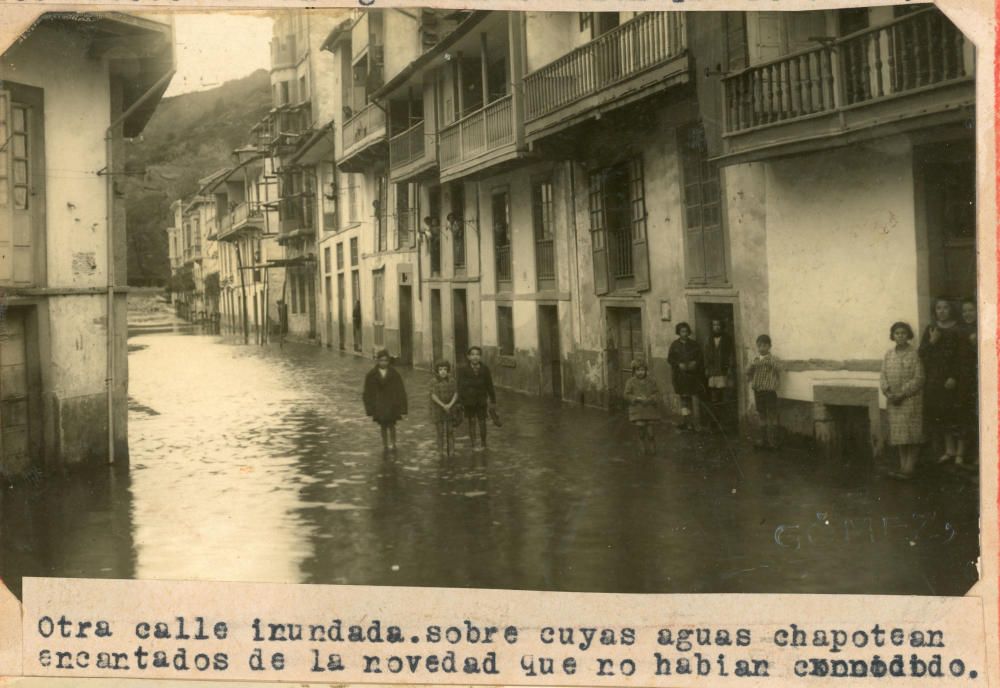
left=881, top=298, right=979, bottom=479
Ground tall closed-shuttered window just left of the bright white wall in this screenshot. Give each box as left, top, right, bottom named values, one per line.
left=678, top=126, right=726, bottom=284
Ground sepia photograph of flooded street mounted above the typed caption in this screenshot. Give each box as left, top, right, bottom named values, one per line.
left=0, top=3, right=984, bottom=596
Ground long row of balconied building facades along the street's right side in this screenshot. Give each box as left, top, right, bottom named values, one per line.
left=175, top=6, right=976, bottom=452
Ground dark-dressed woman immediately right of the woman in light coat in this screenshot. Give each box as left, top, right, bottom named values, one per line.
left=920, top=298, right=965, bottom=463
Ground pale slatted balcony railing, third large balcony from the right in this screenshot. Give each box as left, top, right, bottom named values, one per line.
left=438, top=95, right=518, bottom=182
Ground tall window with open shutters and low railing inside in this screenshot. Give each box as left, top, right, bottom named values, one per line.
left=588, top=156, right=649, bottom=294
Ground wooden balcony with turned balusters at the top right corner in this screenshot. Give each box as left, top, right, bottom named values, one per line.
left=723, top=8, right=975, bottom=160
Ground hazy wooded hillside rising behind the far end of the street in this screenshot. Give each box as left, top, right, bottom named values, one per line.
left=123, top=70, right=271, bottom=286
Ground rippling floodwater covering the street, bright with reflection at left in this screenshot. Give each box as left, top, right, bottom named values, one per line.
left=0, top=328, right=978, bottom=595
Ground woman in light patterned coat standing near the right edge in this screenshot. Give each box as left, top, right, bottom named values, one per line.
left=880, top=322, right=924, bottom=479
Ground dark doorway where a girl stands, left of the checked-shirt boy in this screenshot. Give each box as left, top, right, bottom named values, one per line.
left=691, top=303, right=740, bottom=430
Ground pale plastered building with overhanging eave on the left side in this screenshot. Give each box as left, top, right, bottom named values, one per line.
left=0, top=13, right=173, bottom=476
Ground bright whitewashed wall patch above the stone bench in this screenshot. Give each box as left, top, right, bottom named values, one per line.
left=765, top=138, right=919, bottom=370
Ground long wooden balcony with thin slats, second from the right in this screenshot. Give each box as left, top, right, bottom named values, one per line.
left=524, top=12, right=690, bottom=141
